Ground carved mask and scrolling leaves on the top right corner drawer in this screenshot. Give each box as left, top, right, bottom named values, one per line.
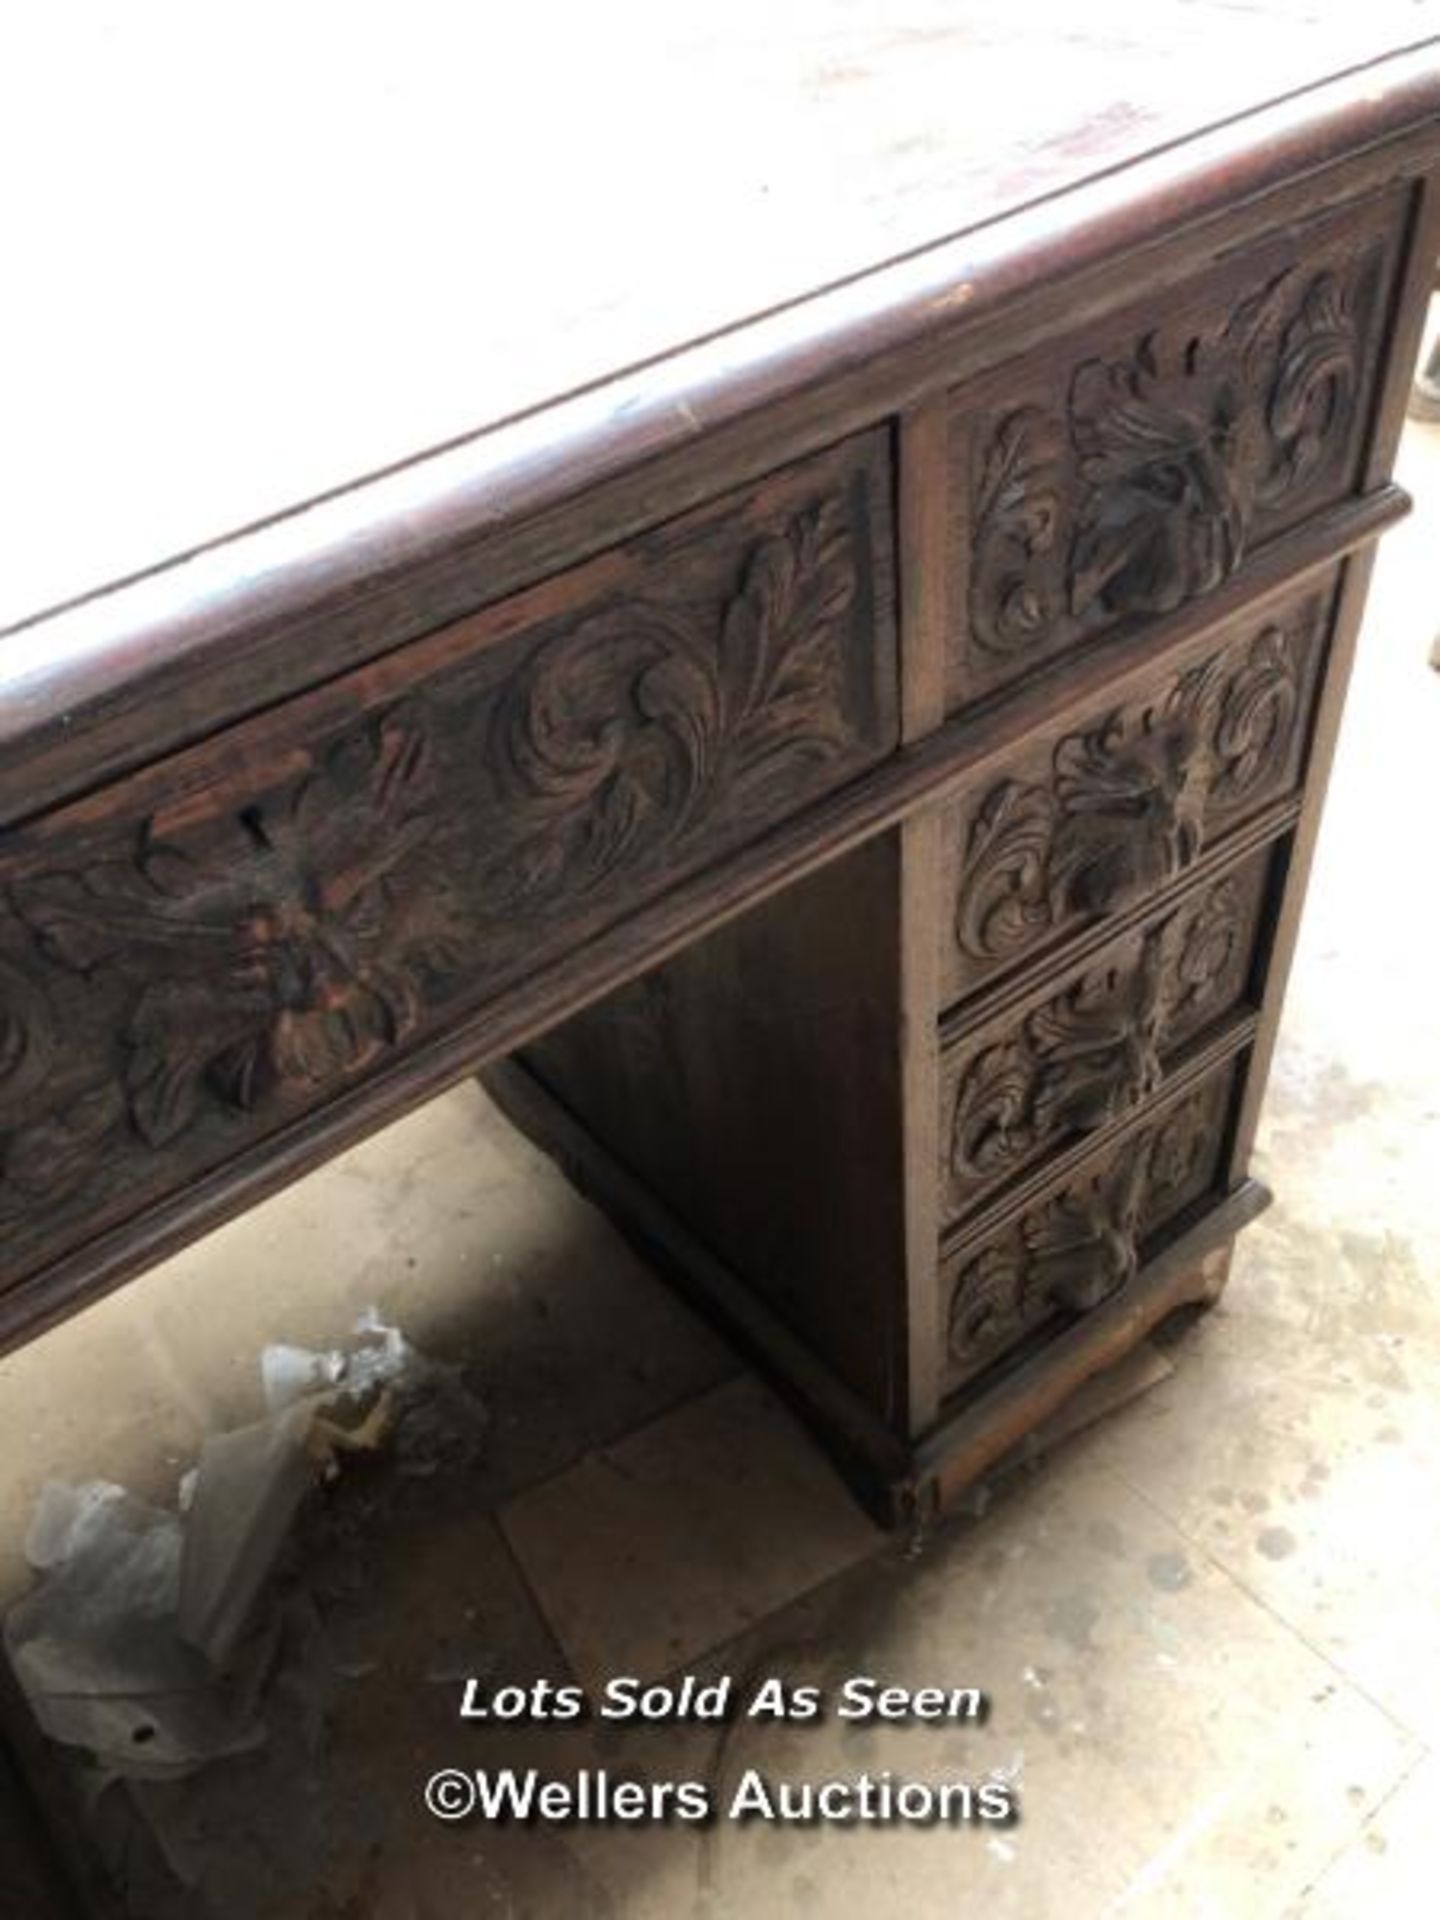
left=970, top=252, right=1379, bottom=657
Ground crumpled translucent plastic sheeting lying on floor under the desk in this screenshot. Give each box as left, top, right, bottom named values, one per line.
left=4, top=1309, right=486, bottom=1780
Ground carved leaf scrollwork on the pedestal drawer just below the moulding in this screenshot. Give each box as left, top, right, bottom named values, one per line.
left=954, top=626, right=1300, bottom=964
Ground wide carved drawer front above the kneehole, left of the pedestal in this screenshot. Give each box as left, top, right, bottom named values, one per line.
left=0, top=432, right=895, bottom=1281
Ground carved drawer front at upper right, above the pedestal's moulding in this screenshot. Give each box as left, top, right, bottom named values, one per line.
left=948, top=183, right=1407, bottom=710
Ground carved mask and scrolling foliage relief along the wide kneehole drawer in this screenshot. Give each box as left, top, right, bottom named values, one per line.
left=0, top=493, right=858, bottom=1206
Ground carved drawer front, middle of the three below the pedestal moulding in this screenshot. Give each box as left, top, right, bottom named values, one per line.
left=941, top=847, right=1273, bottom=1223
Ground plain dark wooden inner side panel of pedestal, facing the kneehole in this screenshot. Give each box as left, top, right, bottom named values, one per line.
left=518, top=833, right=908, bottom=1432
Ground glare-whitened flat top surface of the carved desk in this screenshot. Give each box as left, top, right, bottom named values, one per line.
left=0, top=0, right=1440, bottom=637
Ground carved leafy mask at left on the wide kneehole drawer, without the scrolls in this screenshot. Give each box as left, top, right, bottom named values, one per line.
left=15, top=714, right=462, bottom=1146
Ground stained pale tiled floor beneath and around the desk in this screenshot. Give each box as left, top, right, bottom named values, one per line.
left=0, top=412, right=1440, bottom=1920
